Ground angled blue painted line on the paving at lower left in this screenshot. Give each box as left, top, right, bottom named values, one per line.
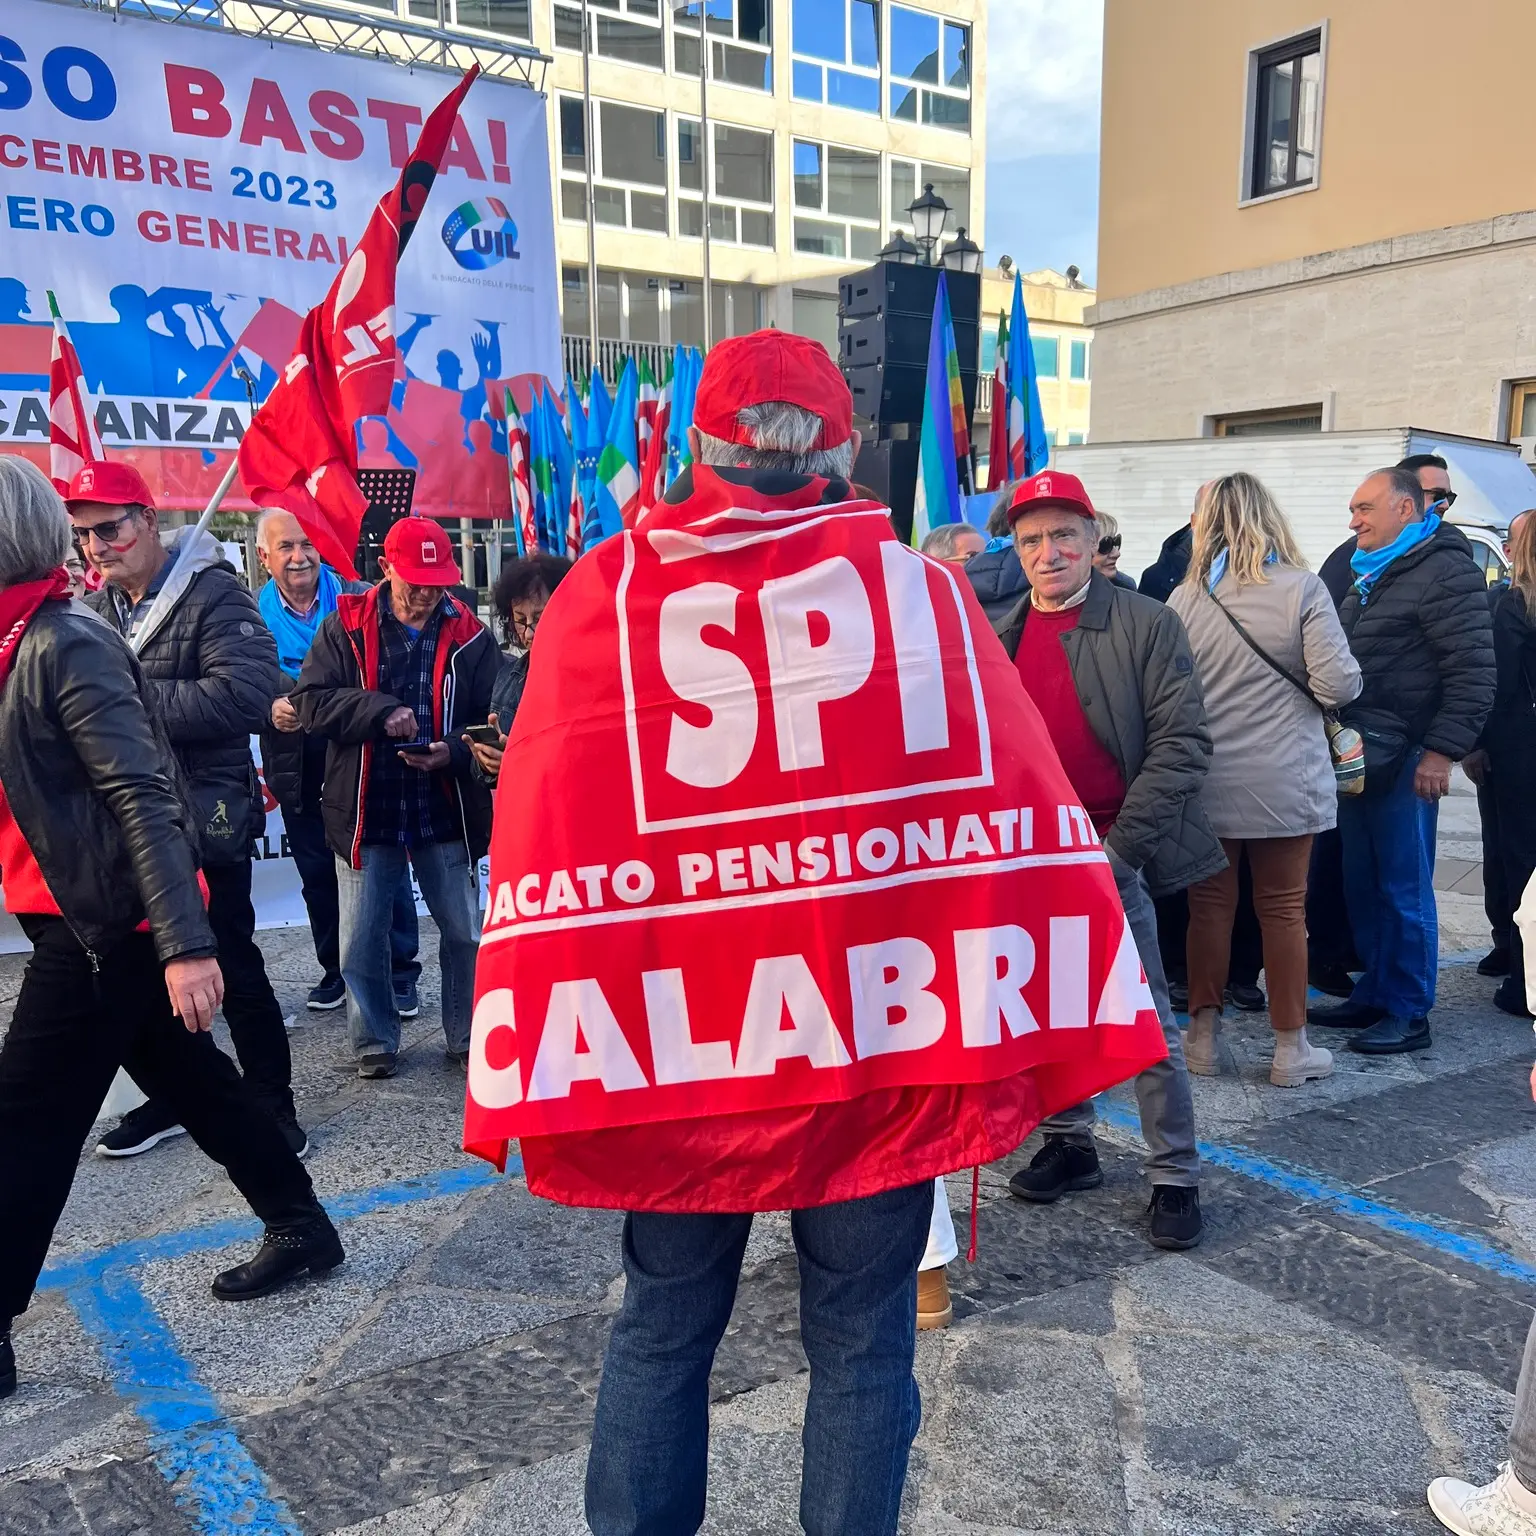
left=37, top=1158, right=522, bottom=1536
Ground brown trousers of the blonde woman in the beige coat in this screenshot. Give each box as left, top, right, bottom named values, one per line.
left=1186, top=833, right=1312, bottom=1029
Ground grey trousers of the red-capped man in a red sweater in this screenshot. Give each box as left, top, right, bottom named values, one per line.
left=1040, top=854, right=1204, bottom=1185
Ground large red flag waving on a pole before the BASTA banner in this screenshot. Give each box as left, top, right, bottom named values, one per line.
left=240, top=65, right=479, bottom=576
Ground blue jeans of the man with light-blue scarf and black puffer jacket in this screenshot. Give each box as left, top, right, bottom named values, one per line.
left=1339, top=751, right=1439, bottom=1018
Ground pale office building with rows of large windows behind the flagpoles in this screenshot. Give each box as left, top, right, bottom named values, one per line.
left=491, top=0, right=986, bottom=366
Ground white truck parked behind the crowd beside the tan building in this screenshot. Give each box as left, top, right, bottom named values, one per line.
left=1051, top=427, right=1536, bottom=584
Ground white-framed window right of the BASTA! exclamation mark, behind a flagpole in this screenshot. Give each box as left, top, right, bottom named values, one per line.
left=561, top=97, right=667, bottom=235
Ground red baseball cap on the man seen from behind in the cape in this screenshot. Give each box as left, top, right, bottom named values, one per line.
left=693, top=330, right=854, bottom=449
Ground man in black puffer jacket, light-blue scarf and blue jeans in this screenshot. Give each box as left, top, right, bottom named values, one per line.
left=1309, top=465, right=1495, bottom=1055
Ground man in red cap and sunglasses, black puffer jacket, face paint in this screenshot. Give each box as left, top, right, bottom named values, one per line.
left=66, top=462, right=307, bottom=1157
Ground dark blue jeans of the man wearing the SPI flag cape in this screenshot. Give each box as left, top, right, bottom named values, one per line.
left=587, top=1180, right=934, bottom=1536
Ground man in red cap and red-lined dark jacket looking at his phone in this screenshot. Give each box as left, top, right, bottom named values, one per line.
left=289, top=518, right=501, bottom=1078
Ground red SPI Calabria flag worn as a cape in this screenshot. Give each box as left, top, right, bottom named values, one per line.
left=464, top=467, right=1164, bottom=1210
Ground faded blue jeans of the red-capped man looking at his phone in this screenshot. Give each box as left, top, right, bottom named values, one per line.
left=336, top=843, right=481, bottom=1057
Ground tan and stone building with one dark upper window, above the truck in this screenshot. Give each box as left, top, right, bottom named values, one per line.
left=1089, top=0, right=1536, bottom=452
